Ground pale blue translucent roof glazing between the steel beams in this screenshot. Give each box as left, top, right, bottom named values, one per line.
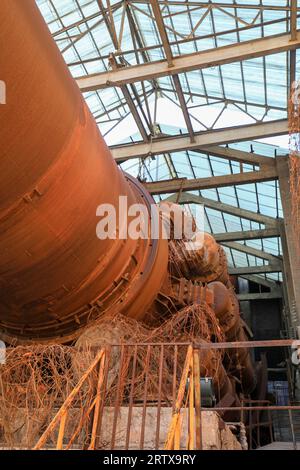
left=36, top=0, right=292, bottom=280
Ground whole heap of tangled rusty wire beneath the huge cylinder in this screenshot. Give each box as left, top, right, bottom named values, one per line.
left=0, top=304, right=224, bottom=448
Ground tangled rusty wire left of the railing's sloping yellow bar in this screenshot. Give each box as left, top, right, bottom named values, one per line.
left=0, top=345, right=95, bottom=448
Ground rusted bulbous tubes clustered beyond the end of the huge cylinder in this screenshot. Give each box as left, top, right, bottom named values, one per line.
left=161, top=202, right=256, bottom=395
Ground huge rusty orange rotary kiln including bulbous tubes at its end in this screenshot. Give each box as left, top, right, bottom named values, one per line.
left=0, top=0, right=255, bottom=404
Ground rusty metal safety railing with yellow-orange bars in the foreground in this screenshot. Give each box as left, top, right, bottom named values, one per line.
left=28, top=340, right=300, bottom=450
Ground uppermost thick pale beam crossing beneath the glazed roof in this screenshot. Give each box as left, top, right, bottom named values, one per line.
left=77, top=32, right=300, bottom=92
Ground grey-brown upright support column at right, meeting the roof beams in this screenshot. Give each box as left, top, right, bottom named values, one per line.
left=276, top=156, right=300, bottom=337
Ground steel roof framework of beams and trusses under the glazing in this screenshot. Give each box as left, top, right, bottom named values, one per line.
left=36, top=0, right=300, bottom=326
